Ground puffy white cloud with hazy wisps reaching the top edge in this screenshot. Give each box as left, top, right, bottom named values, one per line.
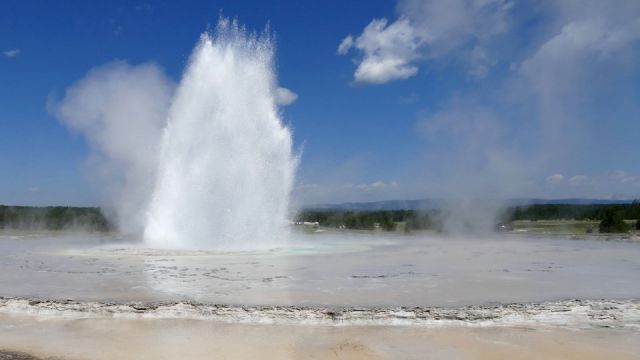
left=338, top=0, right=511, bottom=84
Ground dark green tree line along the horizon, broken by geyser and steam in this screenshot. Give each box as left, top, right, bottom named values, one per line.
left=0, top=201, right=640, bottom=233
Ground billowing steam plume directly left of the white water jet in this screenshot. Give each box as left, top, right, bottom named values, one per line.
left=53, top=61, right=175, bottom=233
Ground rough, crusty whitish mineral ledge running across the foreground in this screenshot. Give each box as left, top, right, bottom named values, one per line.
left=0, top=298, right=640, bottom=327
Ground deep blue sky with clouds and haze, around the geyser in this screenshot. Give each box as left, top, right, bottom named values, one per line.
left=0, top=0, right=640, bottom=205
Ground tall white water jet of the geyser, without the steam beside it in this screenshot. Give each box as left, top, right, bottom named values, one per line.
left=144, top=19, right=296, bottom=249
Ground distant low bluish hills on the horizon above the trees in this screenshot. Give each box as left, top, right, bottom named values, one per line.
left=304, top=198, right=637, bottom=211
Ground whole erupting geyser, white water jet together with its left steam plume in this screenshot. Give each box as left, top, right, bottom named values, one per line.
left=54, top=19, right=296, bottom=250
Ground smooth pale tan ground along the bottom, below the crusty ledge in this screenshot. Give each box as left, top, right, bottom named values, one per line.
left=0, top=314, right=640, bottom=360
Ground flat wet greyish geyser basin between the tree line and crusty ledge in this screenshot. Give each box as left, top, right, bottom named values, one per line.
left=0, top=232, right=640, bottom=307
